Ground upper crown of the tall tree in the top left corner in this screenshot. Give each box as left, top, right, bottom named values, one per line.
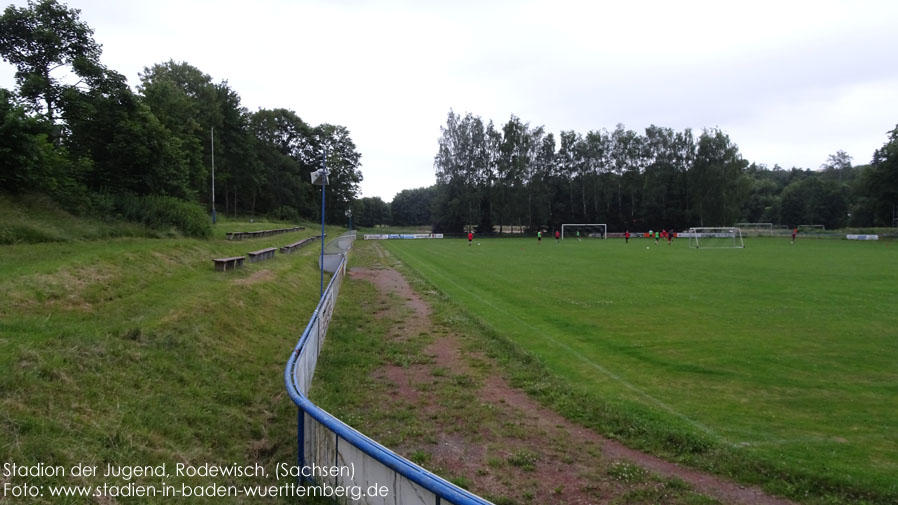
left=0, top=0, right=101, bottom=130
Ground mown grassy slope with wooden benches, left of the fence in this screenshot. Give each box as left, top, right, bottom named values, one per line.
left=0, top=212, right=336, bottom=503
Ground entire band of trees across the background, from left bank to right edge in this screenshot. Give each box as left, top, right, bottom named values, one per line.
left=0, top=0, right=898, bottom=232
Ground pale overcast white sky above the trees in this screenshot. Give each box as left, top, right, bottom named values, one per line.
left=0, top=0, right=898, bottom=202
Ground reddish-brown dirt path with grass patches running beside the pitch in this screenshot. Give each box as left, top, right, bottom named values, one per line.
left=350, top=242, right=793, bottom=505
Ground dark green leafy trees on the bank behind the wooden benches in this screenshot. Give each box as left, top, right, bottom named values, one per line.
left=0, top=0, right=362, bottom=232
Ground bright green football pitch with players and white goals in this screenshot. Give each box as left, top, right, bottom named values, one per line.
left=386, top=238, right=898, bottom=501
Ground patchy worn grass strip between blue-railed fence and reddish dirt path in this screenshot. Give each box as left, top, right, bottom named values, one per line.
left=310, top=241, right=717, bottom=504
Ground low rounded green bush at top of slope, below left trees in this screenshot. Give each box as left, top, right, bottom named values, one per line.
left=109, top=194, right=212, bottom=238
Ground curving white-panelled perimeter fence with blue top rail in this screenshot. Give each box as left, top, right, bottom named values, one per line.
left=284, top=235, right=491, bottom=505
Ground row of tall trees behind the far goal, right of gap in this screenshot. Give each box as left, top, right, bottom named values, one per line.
left=424, top=111, right=898, bottom=232
